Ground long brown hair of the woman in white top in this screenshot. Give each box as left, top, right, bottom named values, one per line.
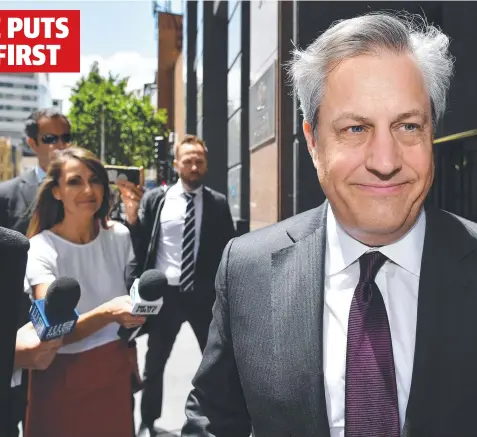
left=27, top=147, right=111, bottom=238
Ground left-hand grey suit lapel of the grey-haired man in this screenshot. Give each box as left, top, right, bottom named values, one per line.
left=271, top=204, right=329, bottom=436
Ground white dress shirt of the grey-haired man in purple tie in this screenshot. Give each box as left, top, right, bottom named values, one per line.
left=323, top=206, right=426, bottom=437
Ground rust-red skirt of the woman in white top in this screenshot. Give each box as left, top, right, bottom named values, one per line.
left=25, top=341, right=136, bottom=437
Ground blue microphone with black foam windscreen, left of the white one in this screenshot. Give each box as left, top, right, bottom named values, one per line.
left=30, top=277, right=81, bottom=341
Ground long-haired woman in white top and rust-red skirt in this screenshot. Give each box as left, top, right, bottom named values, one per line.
left=25, top=147, right=145, bottom=437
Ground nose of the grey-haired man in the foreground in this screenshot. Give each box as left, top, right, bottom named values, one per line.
left=366, top=129, right=402, bottom=176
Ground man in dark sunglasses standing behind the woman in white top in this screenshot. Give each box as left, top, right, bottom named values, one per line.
left=0, top=108, right=71, bottom=436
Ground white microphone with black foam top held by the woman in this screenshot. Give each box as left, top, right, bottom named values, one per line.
left=118, top=269, right=167, bottom=342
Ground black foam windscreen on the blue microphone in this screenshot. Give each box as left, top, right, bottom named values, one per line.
left=45, top=277, right=81, bottom=323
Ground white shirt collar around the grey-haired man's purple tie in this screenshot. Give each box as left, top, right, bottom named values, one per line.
left=325, top=204, right=426, bottom=276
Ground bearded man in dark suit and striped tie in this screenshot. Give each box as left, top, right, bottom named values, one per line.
left=118, top=135, right=235, bottom=436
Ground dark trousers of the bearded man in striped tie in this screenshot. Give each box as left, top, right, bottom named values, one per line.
left=141, top=287, right=213, bottom=427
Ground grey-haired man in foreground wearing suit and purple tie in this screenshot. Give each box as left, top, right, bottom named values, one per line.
left=182, top=14, right=470, bottom=437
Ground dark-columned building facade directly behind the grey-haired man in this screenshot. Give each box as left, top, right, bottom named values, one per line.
left=165, top=0, right=477, bottom=232
